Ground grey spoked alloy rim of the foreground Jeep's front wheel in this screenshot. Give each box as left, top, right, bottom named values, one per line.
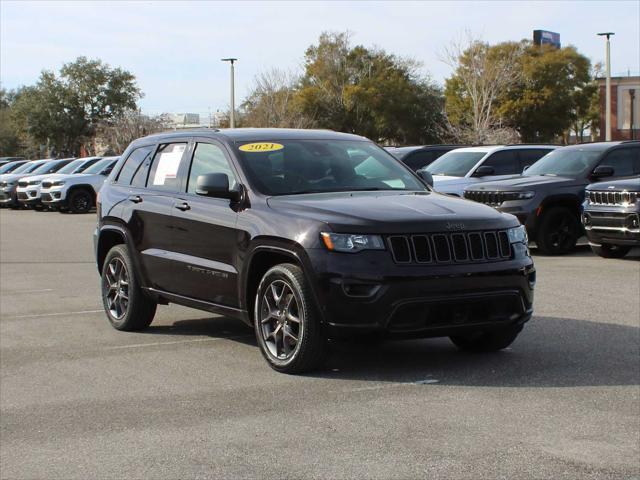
left=260, top=280, right=304, bottom=360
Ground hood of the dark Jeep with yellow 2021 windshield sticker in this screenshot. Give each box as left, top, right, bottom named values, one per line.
left=267, top=192, right=518, bottom=234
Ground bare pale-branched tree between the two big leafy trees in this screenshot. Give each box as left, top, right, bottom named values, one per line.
left=443, top=33, right=525, bottom=143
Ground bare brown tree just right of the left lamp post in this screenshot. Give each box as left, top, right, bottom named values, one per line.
left=241, top=68, right=313, bottom=128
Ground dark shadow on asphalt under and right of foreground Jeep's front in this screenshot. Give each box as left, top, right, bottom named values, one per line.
left=312, top=317, right=640, bottom=387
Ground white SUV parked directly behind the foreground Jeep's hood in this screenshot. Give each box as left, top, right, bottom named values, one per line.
left=422, top=145, right=558, bottom=197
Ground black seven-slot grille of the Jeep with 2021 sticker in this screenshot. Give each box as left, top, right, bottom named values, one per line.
left=387, top=230, right=511, bottom=264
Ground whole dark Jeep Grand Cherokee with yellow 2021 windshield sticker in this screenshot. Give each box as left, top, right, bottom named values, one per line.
left=95, top=129, right=535, bottom=373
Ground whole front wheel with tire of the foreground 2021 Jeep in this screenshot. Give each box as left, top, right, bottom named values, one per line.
left=254, top=263, right=326, bottom=374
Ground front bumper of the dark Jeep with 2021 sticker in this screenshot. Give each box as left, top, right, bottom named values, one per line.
left=308, top=246, right=536, bottom=337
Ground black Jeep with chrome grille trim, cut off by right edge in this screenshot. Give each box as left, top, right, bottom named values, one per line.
left=582, top=177, right=640, bottom=258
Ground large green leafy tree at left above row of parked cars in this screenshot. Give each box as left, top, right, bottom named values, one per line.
left=13, top=57, right=142, bottom=155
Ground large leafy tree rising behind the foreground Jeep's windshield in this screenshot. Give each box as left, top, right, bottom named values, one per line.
left=293, top=33, right=443, bottom=144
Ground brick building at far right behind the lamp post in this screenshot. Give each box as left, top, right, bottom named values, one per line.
left=598, top=76, right=640, bottom=141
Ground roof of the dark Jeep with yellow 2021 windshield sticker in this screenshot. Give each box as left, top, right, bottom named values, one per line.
left=138, top=128, right=368, bottom=142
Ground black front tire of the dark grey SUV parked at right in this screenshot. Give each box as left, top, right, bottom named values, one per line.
left=536, top=207, right=580, bottom=255
